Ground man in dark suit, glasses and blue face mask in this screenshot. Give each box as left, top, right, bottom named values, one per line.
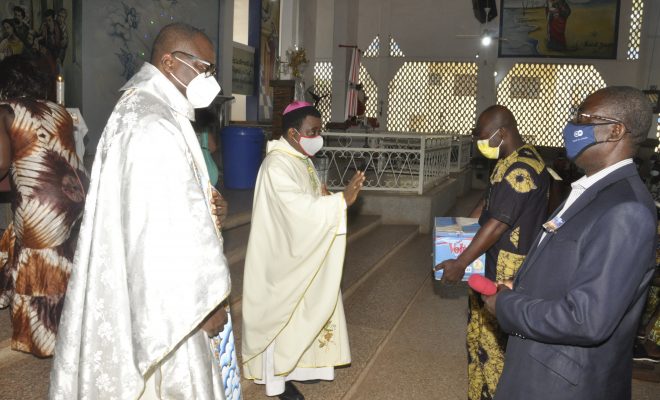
left=483, top=87, right=657, bottom=400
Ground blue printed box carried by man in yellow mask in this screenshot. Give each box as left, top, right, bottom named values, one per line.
left=433, top=217, right=486, bottom=281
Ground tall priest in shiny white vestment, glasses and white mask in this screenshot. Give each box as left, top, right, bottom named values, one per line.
left=50, top=24, right=235, bottom=400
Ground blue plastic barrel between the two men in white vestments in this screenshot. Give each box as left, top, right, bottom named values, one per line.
left=220, top=125, right=264, bottom=189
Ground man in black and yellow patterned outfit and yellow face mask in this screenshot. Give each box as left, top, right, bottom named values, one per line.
left=435, top=105, right=550, bottom=400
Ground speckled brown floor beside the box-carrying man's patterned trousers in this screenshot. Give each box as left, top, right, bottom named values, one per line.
left=343, top=276, right=467, bottom=400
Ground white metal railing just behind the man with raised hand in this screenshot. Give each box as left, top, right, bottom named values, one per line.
left=315, top=132, right=454, bottom=194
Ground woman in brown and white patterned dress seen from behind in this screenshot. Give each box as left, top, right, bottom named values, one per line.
left=0, top=56, right=88, bottom=357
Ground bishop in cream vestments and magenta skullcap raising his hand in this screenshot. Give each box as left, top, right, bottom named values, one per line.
left=242, top=102, right=364, bottom=400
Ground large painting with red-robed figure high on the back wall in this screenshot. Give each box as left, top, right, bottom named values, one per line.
left=499, top=0, right=620, bottom=59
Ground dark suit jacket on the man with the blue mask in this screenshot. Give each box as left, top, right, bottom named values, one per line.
left=496, top=165, right=656, bottom=400
